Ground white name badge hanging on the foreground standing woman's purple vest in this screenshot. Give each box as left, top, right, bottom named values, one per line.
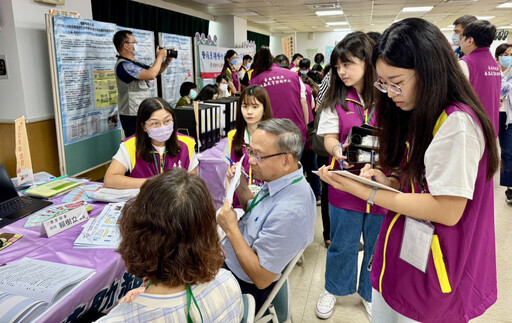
left=400, top=217, right=434, bottom=272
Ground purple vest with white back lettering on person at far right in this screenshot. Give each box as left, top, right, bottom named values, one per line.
left=461, top=47, right=501, bottom=137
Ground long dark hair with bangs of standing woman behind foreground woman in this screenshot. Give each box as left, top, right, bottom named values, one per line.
left=322, top=31, right=376, bottom=111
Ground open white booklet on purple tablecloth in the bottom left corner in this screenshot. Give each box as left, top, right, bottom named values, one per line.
left=0, top=258, right=95, bottom=322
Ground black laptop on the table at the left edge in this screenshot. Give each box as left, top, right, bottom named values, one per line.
left=0, top=164, right=53, bottom=228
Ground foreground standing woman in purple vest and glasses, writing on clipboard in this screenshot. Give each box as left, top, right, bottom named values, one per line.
left=319, top=18, right=498, bottom=323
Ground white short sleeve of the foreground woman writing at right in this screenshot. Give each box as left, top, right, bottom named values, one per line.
left=424, top=111, right=485, bottom=200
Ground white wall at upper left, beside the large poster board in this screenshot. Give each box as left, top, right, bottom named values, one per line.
left=0, top=0, right=92, bottom=122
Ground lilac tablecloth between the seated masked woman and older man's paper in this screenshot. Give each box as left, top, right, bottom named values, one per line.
left=197, top=138, right=228, bottom=209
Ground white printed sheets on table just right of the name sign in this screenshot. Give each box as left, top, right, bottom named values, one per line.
left=74, top=202, right=125, bottom=249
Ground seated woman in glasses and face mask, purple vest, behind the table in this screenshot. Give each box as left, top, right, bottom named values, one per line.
left=104, top=98, right=199, bottom=189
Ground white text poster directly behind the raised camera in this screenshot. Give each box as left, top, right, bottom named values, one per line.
left=159, top=33, right=194, bottom=107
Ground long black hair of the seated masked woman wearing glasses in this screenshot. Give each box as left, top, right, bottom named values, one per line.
left=135, top=98, right=181, bottom=162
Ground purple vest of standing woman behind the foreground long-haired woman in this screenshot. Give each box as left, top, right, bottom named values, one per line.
left=329, top=88, right=387, bottom=214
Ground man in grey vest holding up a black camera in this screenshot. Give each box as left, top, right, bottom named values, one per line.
left=113, top=30, right=176, bottom=137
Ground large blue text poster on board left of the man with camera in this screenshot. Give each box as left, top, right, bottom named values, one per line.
left=53, top=16, right=120, bottom=145
